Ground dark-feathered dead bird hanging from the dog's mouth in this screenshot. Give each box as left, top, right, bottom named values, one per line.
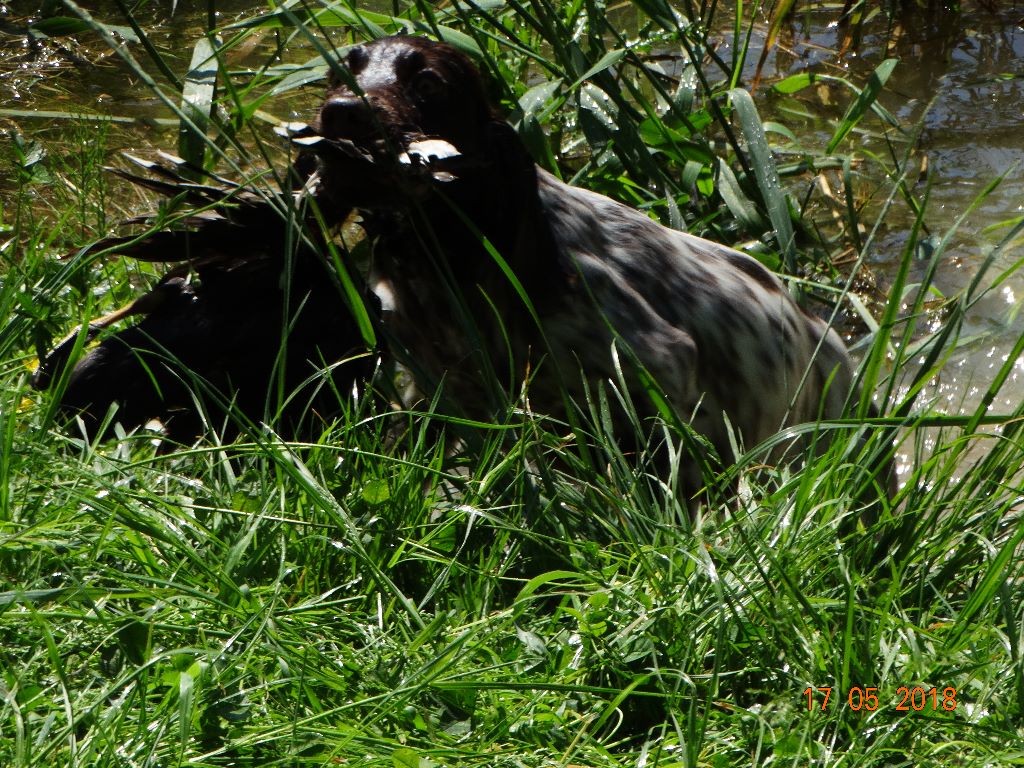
left=32, top=163, right=376, bottom=450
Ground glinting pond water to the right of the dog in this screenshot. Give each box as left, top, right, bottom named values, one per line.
left=745, top=2, right=1024, bottom=430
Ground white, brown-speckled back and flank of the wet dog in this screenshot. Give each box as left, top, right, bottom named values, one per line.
left=539, top=172, right=853, bottom=460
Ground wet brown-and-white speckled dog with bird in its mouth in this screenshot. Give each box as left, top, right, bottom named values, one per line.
left=311, top=36, right=880, bottom=489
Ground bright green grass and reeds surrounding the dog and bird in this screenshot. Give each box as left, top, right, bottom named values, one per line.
left=6, top=2, right=1024, bottom=768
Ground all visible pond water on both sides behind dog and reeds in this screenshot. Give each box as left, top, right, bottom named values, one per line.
left=0, top=0, right=1024, bottom=444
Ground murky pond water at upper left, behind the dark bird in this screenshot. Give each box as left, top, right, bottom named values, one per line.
left=0, top=0, right=313, bottom=201
